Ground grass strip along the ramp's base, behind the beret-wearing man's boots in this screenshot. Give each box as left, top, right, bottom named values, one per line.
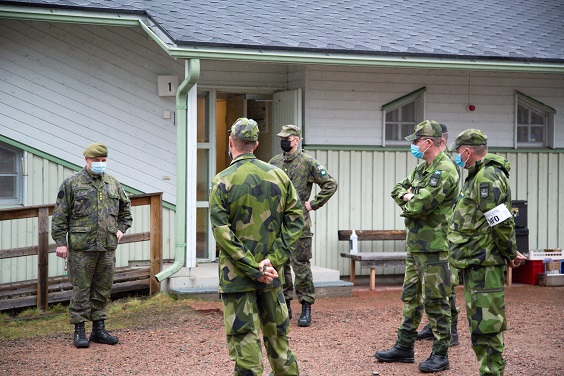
left=0, top=293, right=192, bottom=340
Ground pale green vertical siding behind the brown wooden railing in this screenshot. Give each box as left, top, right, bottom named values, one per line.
left=0, top=153, right=175, bottom=283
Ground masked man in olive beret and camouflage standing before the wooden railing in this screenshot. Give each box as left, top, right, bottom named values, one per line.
left=51, top=143, right=132, bottom=348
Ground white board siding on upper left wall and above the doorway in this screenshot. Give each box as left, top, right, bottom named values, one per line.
left=0, top=19, right=294, bottom=203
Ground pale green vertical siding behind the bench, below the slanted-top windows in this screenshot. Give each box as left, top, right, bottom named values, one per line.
left=306, top=150, right=564, bottom=275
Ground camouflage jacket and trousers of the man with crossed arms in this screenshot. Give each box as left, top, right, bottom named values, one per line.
left=391, top=150, right=458, bottom=355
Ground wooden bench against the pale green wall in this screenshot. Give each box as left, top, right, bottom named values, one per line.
left=338, top=230, right=407, bottom=291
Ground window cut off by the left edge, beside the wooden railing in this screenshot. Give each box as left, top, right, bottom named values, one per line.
left=0, top=142, right=22, bottom=206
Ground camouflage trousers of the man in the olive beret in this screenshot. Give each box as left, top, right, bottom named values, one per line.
left=68, top=250, right=116, bottom=324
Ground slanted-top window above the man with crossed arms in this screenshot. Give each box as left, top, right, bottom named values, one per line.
left=382, top=87, right=426, bottom=145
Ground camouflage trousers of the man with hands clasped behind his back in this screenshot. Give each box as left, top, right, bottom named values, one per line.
left=221, top=287, right=299, bottom=376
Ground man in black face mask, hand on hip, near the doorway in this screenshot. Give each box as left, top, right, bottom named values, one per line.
left=269, top=125, right=337, bottom=326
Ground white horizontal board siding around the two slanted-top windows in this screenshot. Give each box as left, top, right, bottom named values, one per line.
left=304, top=66, right=564, bottom=147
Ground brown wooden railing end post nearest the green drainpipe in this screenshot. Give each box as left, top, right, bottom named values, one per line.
left=149, top=193, right=163, bottom=295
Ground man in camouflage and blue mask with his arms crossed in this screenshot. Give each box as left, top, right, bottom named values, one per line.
left=375, top=120, right=458, bottom=372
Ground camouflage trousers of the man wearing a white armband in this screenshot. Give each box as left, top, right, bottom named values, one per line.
left=462, top=265, right=507, bottom=376
